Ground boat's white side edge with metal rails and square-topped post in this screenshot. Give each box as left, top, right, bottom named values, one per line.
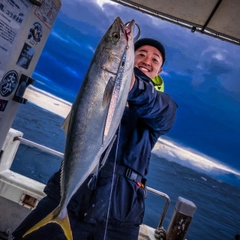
left=0, top=128, right=196, bottom=240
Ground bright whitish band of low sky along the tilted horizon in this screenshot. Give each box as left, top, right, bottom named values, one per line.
left=23, top=86, right=240, bottom=188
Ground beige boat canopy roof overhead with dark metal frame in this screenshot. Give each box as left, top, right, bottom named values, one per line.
left=112, top=0, right=240, bottom=44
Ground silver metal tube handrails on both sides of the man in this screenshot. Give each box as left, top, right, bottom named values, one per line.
left=14, top=137, right=170, bottom=228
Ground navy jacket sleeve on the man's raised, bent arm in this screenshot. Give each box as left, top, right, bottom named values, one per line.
left=128, top=70, right=178, bottom=137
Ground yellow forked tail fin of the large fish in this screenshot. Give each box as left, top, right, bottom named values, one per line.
left=23, top=206, right=73, bottom=240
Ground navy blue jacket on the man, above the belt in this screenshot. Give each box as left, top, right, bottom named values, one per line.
left=109, top=68, right=177, bottom=176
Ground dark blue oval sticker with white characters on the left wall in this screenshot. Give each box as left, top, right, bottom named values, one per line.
left=0, top=70, right=18, bottom=97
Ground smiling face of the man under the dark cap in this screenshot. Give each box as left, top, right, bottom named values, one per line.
left=134, top=45, right=163, bottom=79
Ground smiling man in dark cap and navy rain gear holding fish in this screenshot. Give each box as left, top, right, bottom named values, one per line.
left=10, top=38, right=177, bottom=240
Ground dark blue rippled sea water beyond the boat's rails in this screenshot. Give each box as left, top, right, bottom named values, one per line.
left=11, top=103, right=240, bottom=240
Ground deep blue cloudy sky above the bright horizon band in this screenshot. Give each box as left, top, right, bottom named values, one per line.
left=33, top=0, right=240, bottom=176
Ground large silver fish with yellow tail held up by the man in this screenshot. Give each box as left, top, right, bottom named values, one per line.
left=23, top=17, right=135, bottom=240
